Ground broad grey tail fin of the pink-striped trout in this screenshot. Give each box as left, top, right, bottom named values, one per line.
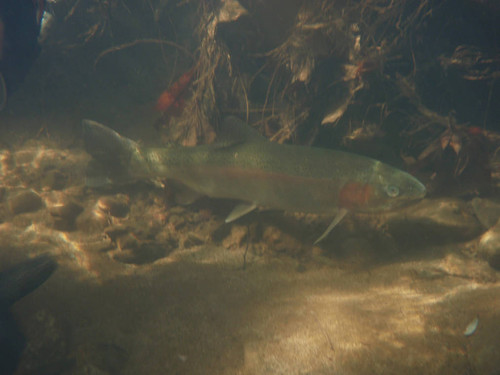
left=82, top=120, right=139, bottom=187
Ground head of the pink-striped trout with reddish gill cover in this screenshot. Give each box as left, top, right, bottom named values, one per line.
left=339, top=161, right=426, bottom=212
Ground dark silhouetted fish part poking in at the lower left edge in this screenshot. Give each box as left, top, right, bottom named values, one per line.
left=0, top=255, right=57, bottom=375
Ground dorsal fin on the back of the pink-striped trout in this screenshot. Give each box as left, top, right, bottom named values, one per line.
left=215, top=116, right=268, bottom=146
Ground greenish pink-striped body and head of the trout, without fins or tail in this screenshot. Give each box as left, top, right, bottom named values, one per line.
left=146, top=142, right=421, bottom=214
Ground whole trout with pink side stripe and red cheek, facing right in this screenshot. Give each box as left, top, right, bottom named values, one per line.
left=82, top=116, right=425, bottom=243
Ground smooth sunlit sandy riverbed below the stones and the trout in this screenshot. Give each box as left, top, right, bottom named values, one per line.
left=7, top=242, right=500, bottom=374
